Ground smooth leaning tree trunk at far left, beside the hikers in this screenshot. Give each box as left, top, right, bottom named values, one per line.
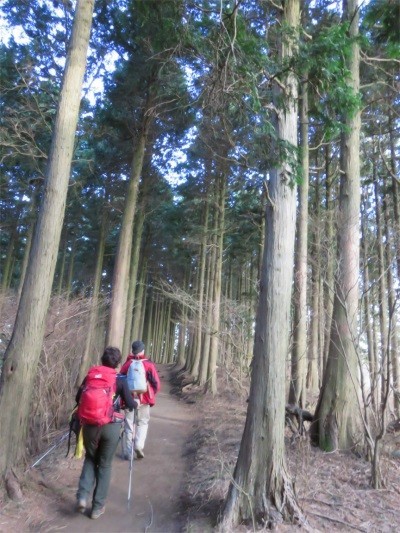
left=0, top=0, right=94, bottom=474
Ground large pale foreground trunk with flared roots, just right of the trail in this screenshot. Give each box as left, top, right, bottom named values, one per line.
left=222, top=0, right=302, bottom=530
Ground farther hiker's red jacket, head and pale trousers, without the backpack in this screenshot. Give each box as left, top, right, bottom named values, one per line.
left=121, top=341, right=160, bottom=460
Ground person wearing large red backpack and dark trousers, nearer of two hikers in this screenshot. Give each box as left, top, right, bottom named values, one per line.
left=76, top=346, right=140, bottom=519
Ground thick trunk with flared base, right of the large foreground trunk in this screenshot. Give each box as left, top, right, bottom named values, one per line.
left=312, top=0, right=362, bottom=450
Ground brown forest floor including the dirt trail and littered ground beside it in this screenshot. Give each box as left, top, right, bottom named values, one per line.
left=0, top=365, right=400, bottom=533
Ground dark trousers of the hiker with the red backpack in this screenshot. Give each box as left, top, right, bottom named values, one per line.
left=77, top=423, right=121, bottom=510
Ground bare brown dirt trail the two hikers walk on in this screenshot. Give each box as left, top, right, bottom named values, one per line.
left=36, top=365, right=193, bottom=533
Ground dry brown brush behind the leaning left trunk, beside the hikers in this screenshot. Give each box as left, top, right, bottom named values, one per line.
left=0, top=288, right=105, bottom=454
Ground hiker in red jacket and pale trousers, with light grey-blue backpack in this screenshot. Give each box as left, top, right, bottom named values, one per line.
left=121, top=340, right=160, bottom=460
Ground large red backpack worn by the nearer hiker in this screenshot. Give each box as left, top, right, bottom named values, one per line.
left=78, top=366, right=117, bottom=426
